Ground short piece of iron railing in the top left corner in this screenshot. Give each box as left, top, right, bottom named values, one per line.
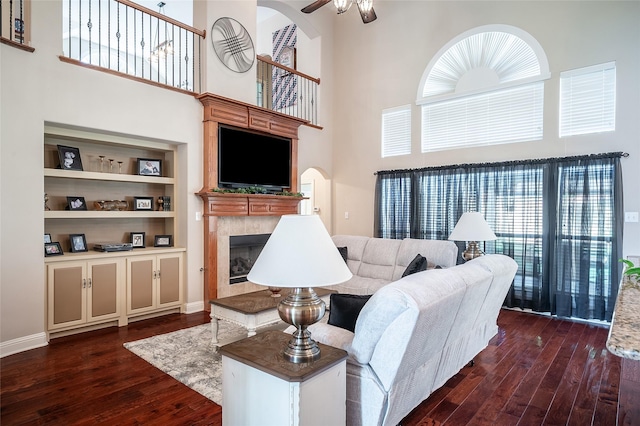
left=0, top=0, right=34, bottom=52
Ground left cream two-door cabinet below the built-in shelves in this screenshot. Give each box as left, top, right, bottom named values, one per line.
left=47, top=258, right=124, bottom=331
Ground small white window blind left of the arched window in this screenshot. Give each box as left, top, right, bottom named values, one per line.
left=382, top=105, right=411, bottom=158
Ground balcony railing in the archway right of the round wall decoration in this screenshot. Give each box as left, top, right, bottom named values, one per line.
left=256, top=55, right=320, bottom=127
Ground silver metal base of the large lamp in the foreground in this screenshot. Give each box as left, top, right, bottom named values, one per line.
left=278, top=287, right=326, bottom=364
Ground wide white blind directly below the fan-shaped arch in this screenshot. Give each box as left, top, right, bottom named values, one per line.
left=422, top=81, right=544, bottom=152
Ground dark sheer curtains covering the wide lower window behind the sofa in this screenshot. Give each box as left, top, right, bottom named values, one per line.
left=374, top=153, right=623, bottom=320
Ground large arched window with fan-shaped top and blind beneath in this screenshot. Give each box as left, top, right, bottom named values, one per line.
left=416, top=25, right=549, bottom=152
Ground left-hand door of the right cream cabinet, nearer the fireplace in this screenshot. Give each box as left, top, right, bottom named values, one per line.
left=127, top=256, right=157, bottom=314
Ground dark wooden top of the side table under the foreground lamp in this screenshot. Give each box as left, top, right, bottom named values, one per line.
left=220, top=331, right=347, bottom=382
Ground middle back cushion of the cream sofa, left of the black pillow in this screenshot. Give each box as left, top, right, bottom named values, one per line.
left=357, top=238, right=400, bottom=281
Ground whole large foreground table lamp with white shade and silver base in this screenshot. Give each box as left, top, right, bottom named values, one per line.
left=247, top=215, right=352, bottom=363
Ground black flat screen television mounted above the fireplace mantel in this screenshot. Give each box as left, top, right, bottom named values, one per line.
left=218, top=126, right=291, bottom=192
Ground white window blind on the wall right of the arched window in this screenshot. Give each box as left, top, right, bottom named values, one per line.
left=560, top=62, right=616, bottom=137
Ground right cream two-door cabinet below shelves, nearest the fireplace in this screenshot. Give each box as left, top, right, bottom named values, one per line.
left=127, top=253, right=183, bottom=315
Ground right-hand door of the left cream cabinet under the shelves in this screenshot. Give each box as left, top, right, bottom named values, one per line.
left=87, top=259, right=123, bottom=321
